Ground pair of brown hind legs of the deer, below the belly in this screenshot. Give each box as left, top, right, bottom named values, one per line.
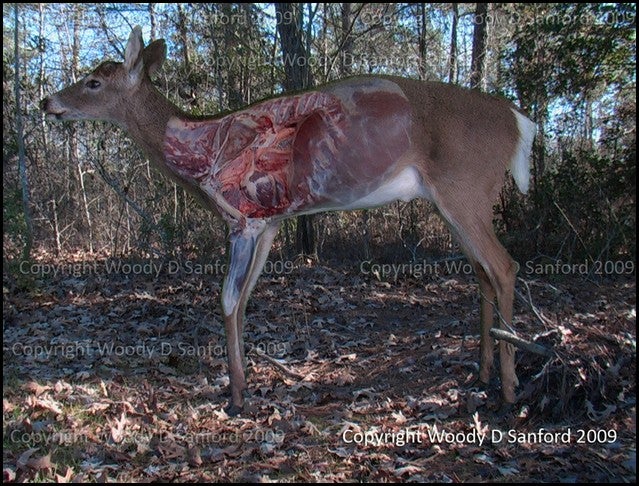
left=438, top=198, right=518, bottom=403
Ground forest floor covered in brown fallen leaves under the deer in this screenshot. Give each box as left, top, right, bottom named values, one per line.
left=3, top=252, right=636, bottom=483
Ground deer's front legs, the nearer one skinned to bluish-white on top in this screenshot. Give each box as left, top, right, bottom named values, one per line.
left=222, top=220, right=279, bottom=415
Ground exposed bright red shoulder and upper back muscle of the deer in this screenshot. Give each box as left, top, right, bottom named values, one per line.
left=164, top=92, right=343, bottom=218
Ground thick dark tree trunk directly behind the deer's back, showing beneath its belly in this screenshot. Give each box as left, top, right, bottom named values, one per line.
left=275, top=3, right=317, bottom=256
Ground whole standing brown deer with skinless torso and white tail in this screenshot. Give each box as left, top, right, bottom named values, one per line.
left=41, top=26, right=536, bottom=415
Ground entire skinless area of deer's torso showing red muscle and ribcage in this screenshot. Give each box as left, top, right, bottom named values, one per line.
left=164, top=78, right=414, bottom=224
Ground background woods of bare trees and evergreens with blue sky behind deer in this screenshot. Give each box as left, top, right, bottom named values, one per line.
left=3, top=3, right=636, bottom=262
